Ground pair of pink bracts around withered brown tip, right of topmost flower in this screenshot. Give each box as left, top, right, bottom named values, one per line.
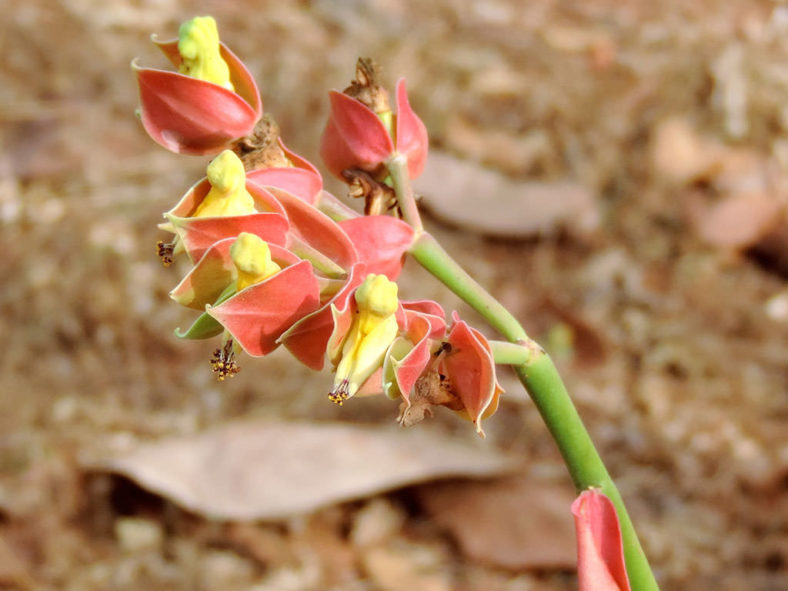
left=320, top=79, right=429, bottom=179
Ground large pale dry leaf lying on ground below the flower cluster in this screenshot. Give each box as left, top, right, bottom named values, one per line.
left=89, top=421, right=516, bottom=519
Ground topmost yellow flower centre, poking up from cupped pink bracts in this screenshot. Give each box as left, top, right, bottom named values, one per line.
left=178, top=16, right=235, bottom=92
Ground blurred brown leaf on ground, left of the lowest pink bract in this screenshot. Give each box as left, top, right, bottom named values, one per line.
left=419, top=476, right=576, bottom=570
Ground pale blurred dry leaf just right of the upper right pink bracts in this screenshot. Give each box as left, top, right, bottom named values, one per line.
left=415, top=151, right=599, bottom=238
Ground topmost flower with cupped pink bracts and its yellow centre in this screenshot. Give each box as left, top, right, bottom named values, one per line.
left=132, top=17, right=263, bottom=155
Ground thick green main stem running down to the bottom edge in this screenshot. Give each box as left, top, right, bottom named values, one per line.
left=410, top=234, right=659, bottom=591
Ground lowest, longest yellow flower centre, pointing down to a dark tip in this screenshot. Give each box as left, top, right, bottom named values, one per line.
left=329, top=274, right=399, bottom=404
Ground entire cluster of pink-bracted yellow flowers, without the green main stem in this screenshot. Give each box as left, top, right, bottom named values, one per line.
left=134, top=17, right=501, bottom=434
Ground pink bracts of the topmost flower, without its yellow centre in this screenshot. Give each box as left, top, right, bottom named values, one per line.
left=132, top=37, right=263, bottom=155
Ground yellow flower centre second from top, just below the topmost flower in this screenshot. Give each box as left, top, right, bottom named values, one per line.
left=194, top=150, right=255, bottom=218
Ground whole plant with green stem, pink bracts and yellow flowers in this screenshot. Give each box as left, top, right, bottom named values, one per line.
left=135, top=17, right=657, bottom=591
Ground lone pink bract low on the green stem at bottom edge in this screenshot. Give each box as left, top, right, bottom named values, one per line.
left=572, top=489, right=630, bottom=591
